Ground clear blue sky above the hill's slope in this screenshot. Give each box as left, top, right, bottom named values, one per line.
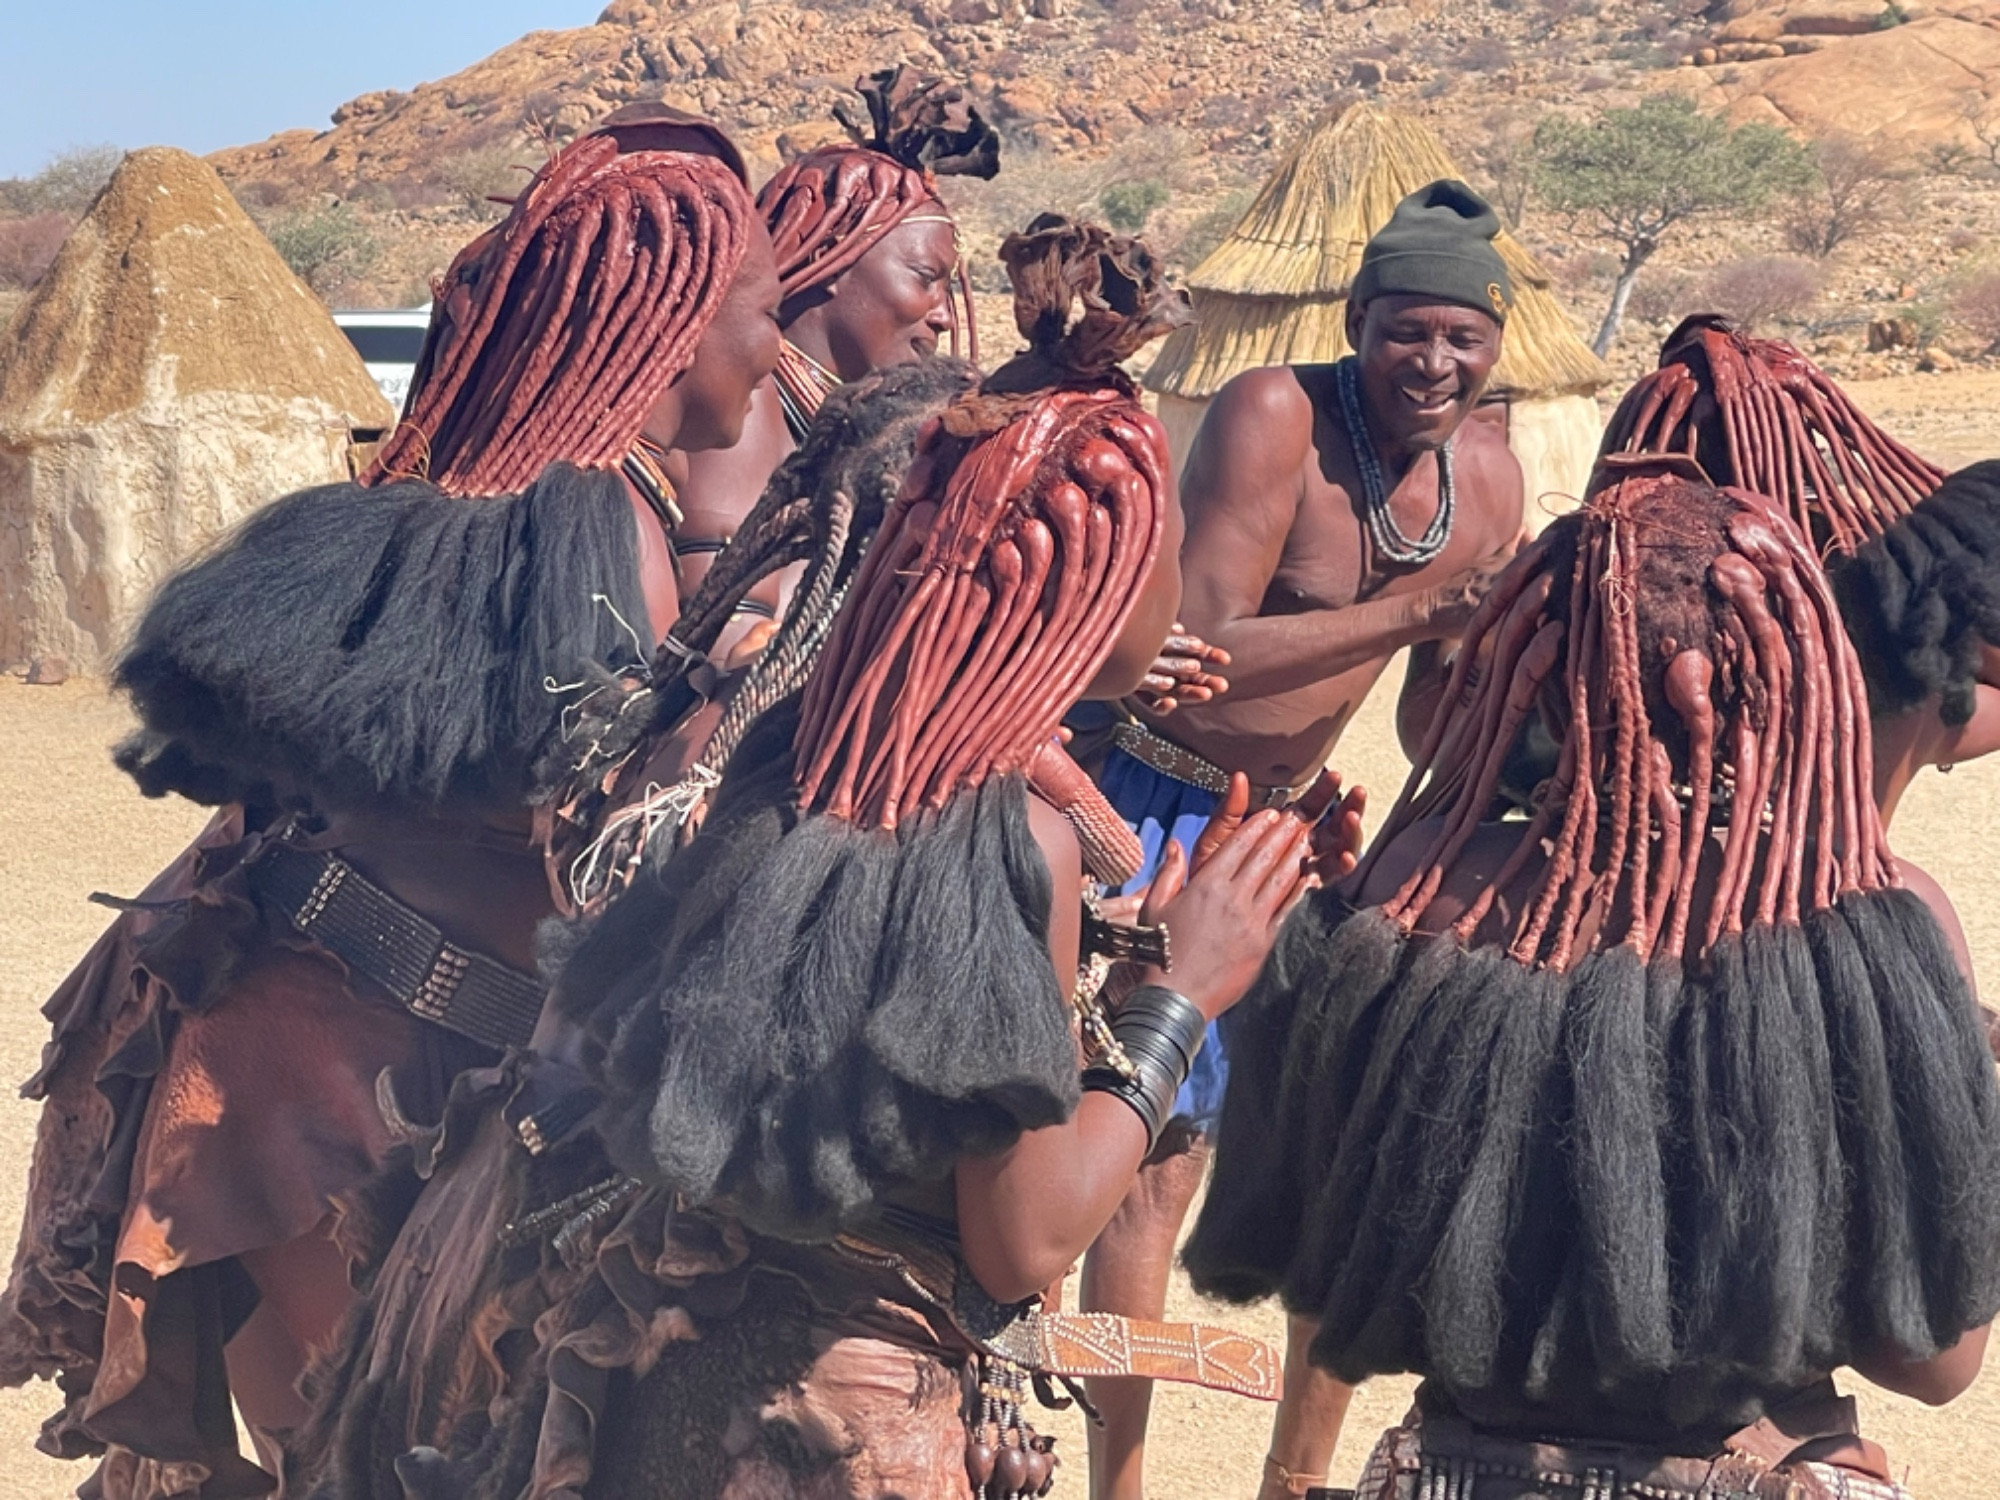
left=0, top=0, right=604, bottom=176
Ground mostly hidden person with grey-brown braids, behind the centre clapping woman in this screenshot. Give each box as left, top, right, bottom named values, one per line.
left=292, top=356, right=978, bottom=1500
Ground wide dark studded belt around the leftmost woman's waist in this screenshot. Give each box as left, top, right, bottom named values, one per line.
left=246, top=844, right=548, bottom=1048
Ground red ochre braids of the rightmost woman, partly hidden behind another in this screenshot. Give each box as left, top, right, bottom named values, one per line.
left=1604, top=314, right=1944, bottom=552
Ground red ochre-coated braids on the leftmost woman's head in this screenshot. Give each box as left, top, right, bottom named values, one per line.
left=364, top=122, right=752, bottom=494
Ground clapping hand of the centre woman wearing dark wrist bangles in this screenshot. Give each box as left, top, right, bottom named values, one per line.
left=1140, top=772, right=1320, bottom=1020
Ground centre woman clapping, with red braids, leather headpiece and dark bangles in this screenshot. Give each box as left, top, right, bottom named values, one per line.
left=312, top=218, right=1336, bottom=1500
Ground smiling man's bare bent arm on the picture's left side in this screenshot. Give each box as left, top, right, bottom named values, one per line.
left=1180, top=368, right=1434, bottom=702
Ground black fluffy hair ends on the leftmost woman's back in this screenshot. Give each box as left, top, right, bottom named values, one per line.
left=116, top=464, right=646, bottom=806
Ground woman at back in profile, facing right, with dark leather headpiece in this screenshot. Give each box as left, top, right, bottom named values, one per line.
left=666, top=66, right=1000, bottom=656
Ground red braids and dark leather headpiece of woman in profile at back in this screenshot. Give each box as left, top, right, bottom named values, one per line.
left=756, top=64, right=1000, bottom=364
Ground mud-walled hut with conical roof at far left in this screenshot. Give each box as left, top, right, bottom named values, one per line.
left=0, top=148, right=394, bottom=672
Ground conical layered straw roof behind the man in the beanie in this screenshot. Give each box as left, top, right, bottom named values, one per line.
left=1146, top=104, right=1610, bottom=400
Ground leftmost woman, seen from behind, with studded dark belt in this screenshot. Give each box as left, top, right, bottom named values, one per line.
left=4, top=108, right=778, bottom=1496
